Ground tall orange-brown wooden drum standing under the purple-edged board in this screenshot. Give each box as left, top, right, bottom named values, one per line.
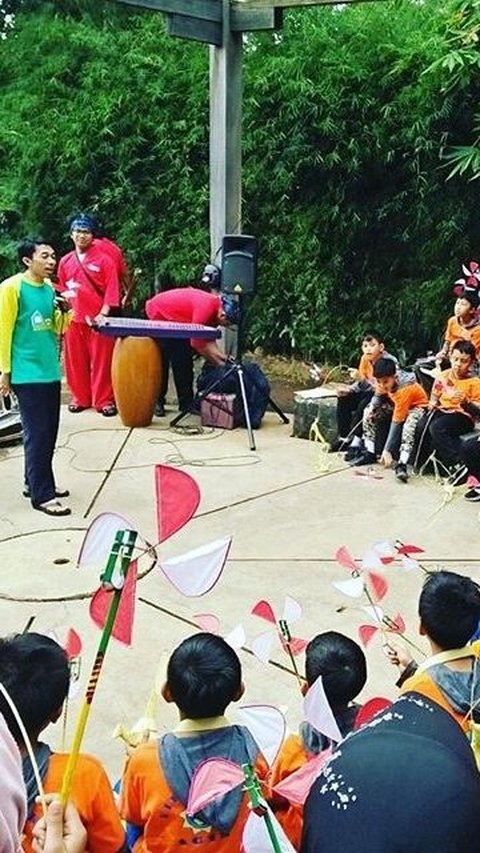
left=112, top=337, right=162, bottom=427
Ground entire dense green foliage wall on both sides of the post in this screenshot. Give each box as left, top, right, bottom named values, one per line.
left=0, top=0, right=480, bottom=362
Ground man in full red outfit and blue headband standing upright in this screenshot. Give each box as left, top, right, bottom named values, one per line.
left=58, top=214, right=120, bottom=417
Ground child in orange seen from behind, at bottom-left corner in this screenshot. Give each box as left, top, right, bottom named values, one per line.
left=0, top=632, right=126, bottom=853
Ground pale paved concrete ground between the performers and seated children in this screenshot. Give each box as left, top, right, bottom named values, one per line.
left=0, top=408, right=480, bottom=774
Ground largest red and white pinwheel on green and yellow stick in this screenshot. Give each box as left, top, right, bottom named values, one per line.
left=61, top=465, right=231, bottom=803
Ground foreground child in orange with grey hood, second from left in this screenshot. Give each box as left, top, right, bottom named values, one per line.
left=120, top=633, right=267, bottom=853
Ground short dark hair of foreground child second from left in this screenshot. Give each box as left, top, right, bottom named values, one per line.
left=167, top=633, right=242, bottom=720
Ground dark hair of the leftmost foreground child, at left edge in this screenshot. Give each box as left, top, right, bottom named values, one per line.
left=0, top=632, right=70, bottom=744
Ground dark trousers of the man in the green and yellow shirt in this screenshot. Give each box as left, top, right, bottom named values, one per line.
left=13, top=382, right=60, bottom=505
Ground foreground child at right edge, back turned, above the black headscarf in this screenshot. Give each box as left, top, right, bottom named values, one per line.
left=386, top=571, right=480, bottom=731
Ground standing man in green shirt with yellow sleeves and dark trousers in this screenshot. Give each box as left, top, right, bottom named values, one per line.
left=0, top=237, right=71, bottom=516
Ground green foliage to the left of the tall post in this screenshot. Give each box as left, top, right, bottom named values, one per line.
left=0, top=0, right=208, bottom=298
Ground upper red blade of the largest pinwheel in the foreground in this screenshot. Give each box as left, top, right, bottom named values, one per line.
left=155, top=465, right=200, bottom=542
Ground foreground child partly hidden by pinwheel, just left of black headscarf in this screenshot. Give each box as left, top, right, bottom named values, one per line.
left=271, top=631, right=367, bottom=849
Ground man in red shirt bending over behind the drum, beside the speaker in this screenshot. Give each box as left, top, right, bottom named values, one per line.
left=145, top=287, right=238, bottom=416
